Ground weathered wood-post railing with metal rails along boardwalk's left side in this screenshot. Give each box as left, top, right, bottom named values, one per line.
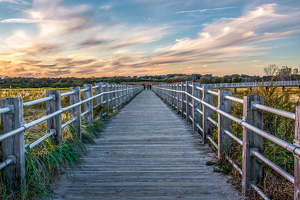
left=0, top=83, right=142, bottom=191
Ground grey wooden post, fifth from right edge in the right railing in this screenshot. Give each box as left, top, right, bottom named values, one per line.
left=192, top=82, right=201, bottom=131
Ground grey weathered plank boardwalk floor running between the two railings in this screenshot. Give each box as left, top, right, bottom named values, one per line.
left=55, top=90, right=243, bottom=200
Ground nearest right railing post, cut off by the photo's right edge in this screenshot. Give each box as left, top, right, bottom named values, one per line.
left=294, top=106, right=300, bottom=200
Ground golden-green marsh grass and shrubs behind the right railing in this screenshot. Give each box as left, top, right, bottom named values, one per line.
left=207, top=83, right=300, bottom=199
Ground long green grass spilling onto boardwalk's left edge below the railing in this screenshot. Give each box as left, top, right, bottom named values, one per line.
left=0, top=120, right=105, bottom=199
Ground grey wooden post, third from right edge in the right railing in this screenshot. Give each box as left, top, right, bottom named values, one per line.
left=218, top=89, right=232, bottom=159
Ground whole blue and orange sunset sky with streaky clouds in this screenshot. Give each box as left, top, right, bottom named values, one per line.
left=0, top=0, right=300, bottom=77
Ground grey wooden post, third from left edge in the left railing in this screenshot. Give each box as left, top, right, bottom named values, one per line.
left=70, top=86, right=82, bottom=140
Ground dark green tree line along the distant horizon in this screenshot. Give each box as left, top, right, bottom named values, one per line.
left=0, top=64, right=299, bottom=88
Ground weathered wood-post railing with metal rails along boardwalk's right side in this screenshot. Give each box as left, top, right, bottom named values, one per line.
left=153, top=82, right=300, bottom=200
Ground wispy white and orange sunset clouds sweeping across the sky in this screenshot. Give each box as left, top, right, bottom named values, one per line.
left=0, top=0, right=300, bottom=77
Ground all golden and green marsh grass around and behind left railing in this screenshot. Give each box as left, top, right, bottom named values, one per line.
left=0, top=89, right=108, bottom=199
